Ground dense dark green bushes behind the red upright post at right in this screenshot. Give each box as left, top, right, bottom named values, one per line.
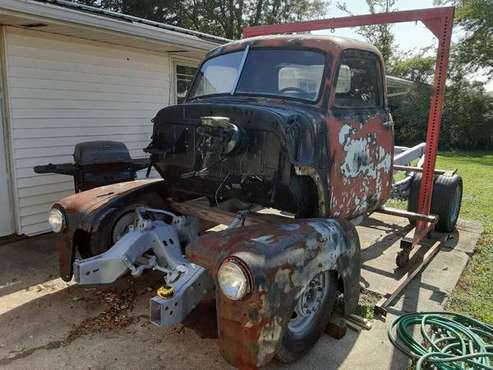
left=390, top=53, right=493, bottom=150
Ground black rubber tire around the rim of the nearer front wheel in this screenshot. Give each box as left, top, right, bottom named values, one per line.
left=276, top=271, right=337, bottom=363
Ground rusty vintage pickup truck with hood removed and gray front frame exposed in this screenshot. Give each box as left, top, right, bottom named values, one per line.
left=49, top=23, right=462, bottom=368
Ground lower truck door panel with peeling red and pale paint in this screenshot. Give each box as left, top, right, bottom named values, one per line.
left=327, top=113, right=394, bottom=218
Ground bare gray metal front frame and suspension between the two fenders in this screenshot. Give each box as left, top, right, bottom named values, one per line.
left=74, top=208, right=214, bottom=326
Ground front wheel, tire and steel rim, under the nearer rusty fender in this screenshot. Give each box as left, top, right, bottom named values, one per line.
left=276, top=271, right=337, bottom=363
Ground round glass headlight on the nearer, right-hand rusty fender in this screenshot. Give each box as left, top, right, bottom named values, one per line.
left=217, top=257, right=250, bottom=301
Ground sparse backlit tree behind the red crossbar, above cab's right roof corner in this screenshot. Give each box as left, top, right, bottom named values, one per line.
left=337, top=0, right=397, bottom=64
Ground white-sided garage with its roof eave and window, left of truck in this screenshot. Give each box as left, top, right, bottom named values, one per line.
left=0, top=0, right=227, bottom=236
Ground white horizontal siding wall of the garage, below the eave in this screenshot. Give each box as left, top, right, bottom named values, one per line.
left=5, top=27, right=178, bottom=235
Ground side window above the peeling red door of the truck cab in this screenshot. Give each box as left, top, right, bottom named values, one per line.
left=334, top=51, right=383, bottom=108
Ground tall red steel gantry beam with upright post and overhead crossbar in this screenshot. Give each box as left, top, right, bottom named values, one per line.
left=243, top=7, right=455, bottom=246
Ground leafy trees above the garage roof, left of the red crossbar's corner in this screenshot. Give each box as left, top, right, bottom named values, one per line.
left=78, top=0, right=328, bottom=39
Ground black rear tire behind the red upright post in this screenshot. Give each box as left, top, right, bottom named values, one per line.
left=407, top=173, right=463, bottom=233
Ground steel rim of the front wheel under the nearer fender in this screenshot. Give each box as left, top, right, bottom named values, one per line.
left=288, top=272, right=329, bottom=335
